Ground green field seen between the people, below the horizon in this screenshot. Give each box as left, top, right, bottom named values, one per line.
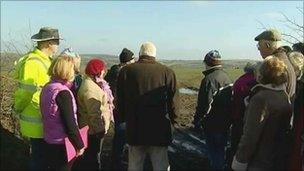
left=1, top=54, right=252, bottom=88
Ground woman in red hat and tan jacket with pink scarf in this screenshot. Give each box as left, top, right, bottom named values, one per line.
left=77, top=59, right=114, bottom=170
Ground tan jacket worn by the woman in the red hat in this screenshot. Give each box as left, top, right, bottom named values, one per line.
left=77, top=77, right=111, bottom=134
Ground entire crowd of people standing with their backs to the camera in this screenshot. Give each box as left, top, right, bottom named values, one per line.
left=14, top=27, right=304, bottom=170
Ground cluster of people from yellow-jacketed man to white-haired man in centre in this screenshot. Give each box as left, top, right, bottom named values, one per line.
left=14, top=27, right=176, bottom=170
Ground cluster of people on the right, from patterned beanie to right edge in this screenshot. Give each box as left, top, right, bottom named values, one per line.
left=193, top=29, right=304, bottom=170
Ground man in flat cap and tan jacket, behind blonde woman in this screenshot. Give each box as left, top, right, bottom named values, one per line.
left=254, top=29, right=296, bottom=100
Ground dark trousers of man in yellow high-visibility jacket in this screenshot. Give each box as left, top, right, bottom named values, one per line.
left=30, top=138, right=47, bottom=170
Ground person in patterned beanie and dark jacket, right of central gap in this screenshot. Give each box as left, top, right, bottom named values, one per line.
left=194, top=50, right=232, bottom=170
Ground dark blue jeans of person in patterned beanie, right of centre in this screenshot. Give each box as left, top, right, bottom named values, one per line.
left=205, top=133, right=227, bottom=170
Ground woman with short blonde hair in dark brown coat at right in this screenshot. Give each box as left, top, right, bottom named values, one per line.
left=232, top=57, right=292, bottom=170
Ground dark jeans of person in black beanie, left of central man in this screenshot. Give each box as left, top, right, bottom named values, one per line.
left=112, top=122, right=126, bottom=170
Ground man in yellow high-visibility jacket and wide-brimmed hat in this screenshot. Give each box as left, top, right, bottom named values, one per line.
left=14, top=27, right=60, bottom=170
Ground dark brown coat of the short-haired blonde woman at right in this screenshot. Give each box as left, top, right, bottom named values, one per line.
left=232, top=84, right=291, bottom=170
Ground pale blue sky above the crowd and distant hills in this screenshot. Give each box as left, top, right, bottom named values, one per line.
left=1, top=1, right=304, bottom=60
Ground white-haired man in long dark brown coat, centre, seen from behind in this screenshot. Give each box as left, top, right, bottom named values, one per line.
left=117, top=42, right=177, bottom=170
